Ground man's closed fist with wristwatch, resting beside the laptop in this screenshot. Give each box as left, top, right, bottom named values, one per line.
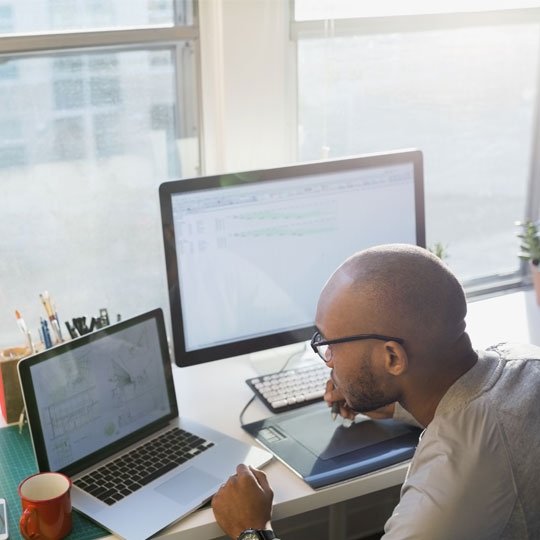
left=212, top=464, right=274, bottom=540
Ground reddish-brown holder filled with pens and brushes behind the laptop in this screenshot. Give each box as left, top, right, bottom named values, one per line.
left=0, top=291, right=121, bottom=424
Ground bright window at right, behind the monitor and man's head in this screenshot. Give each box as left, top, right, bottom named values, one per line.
left=292, top=0, right=540, bottom=294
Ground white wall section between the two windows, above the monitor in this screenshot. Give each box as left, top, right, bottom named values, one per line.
left=199, top=0, right=296, bottom=174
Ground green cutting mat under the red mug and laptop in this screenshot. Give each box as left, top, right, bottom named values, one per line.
left=0, top=425, right=109, bottom=540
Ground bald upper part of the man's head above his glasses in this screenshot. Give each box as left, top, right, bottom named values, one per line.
left=317, top=244, right=467, bottom=356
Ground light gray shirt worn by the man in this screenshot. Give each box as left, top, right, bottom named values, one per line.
left=383, top=344, right=540, bottom=540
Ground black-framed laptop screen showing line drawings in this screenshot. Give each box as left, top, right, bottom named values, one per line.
left=19, top=310, right=177, bottom=471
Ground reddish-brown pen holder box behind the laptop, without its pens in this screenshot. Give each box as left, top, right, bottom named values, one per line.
left=0, top=347, right=31, bottom=424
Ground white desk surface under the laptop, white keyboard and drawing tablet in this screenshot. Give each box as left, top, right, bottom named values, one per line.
left=1, top=291, right=540, bottom=540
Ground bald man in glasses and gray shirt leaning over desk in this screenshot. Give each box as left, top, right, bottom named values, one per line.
left=213, top=245, right=540, bottom=540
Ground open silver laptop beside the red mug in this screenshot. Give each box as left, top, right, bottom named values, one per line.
left=18, top=309, right=271, bottom=540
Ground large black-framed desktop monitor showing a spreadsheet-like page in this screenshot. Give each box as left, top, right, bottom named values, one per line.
left=159, top=150, right=425, bottom=366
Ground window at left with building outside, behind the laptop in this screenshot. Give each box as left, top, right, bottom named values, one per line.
left=0, top=0, right=199, bottom=347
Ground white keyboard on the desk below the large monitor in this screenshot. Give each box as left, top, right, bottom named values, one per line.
left=246, top=363, right=330, bottom=413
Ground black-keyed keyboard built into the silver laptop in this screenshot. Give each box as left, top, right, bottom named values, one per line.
left=73, top=428, right=214, bottom=505
